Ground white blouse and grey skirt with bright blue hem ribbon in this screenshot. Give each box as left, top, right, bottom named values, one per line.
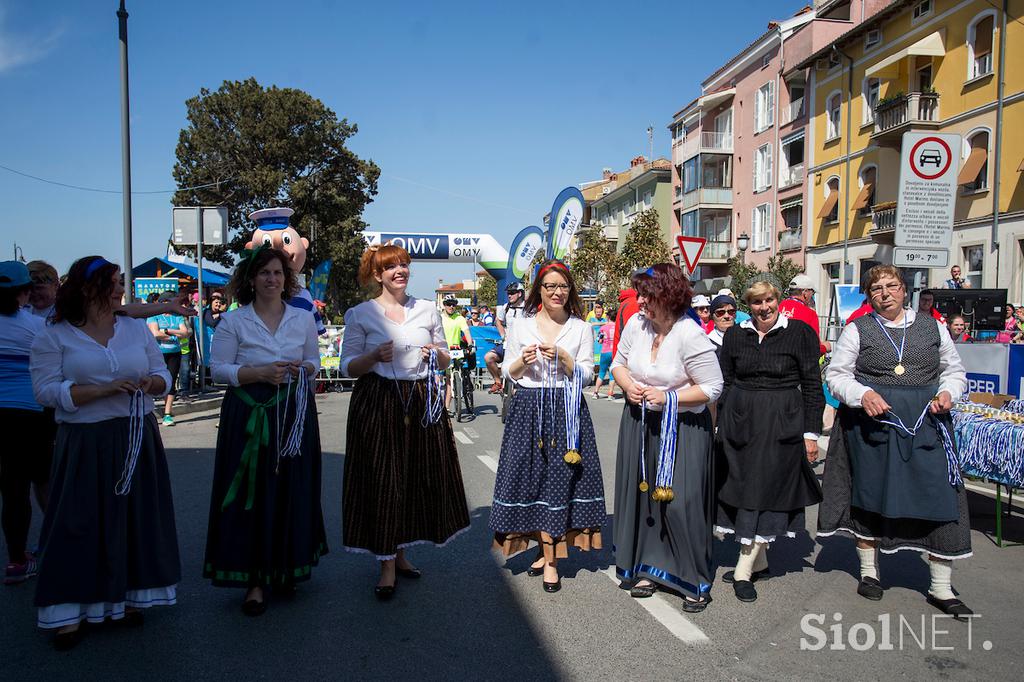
left=611, top=313, right=723, bottom=599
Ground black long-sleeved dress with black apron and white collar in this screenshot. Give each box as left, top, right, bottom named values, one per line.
left=715, top=314, right=824, bottom=545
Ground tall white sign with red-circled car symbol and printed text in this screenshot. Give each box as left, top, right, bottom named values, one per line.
left=894, top=132, right=961, bottom=253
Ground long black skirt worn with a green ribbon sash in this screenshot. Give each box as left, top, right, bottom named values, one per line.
left=203, top=384, right=328, bottom=587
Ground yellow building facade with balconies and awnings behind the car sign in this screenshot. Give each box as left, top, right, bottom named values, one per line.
left=794, top=0, right=1024, bottom=301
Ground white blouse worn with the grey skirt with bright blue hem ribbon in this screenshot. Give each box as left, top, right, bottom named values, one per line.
left=611, top=313, right=724, bottom=413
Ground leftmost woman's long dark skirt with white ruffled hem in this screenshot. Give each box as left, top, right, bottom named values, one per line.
left=36, top=414, right=181, bottom=628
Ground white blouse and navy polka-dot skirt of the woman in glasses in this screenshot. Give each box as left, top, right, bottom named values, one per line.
left=489, top=316, right=605, bottom=562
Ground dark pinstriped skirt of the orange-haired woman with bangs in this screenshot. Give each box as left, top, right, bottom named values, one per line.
left=342, top=373, right=469, bottom=560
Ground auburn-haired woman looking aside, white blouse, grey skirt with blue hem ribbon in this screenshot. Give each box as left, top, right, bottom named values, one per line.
left=611, top=263, right=722, bottom=612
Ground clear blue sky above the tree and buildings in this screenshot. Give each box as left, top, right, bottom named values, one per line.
left=0, top=0, right=801, bottom=295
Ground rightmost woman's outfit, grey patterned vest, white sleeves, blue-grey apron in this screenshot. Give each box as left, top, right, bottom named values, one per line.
left=818, top=310, right=971, bottom=559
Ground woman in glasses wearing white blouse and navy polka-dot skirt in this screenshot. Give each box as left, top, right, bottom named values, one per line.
left=490, top=260, right=605, bottom=592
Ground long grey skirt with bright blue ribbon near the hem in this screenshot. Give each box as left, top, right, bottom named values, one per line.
left=614, top=404, right=715, bottom=599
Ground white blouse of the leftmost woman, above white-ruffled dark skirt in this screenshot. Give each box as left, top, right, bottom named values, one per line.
left=29, top=315, right=171, bottom=424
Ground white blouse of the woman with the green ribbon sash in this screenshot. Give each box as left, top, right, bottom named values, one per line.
left=210, top=305, right=319, bottom=386
